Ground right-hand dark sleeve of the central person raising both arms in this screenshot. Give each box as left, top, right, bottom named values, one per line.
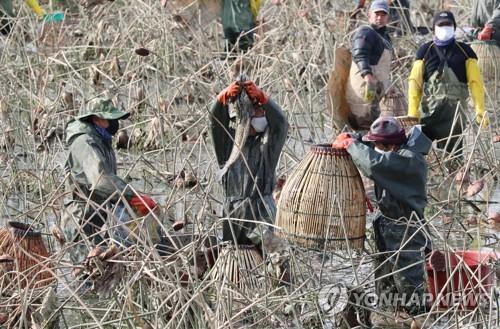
left=262, top=99, right=288, bottom=166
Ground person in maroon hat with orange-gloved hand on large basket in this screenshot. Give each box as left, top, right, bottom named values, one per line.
left=332, top=117, right=432, bottom=328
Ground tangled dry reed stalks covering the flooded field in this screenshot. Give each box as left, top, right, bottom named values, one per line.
left=0, top=0, right=500, bottom=329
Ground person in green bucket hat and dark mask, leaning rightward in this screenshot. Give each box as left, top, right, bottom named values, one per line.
left=61, top=98, right=157, bottom=264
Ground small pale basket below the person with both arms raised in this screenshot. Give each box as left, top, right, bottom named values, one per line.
left=212, top=244, right=265, bottom=293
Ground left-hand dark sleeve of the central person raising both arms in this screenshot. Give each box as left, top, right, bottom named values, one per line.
left=210, top=100, right=233, bottom=166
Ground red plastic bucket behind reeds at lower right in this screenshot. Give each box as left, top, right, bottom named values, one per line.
left=426, top=250, right=499, bottom=310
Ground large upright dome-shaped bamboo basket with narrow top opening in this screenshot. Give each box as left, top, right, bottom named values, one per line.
left=276, top=144, right=366, bottom=250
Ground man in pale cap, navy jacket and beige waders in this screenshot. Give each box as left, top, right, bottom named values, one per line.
left=346, top=0, right=392, bottom=130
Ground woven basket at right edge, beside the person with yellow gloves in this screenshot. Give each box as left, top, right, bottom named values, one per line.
left=471, top=41, right=500, bottom=81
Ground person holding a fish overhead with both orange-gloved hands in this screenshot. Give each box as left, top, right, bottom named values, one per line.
left=210, top=80, right=288, bottom=248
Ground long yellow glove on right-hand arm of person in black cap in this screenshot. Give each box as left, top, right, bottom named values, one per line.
left=465, top=58, right=490, bottom=127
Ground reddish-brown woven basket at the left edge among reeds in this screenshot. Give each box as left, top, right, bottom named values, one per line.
left=0, top=222, right=55, bottom=288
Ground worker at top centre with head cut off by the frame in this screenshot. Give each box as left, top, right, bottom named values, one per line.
left=221, top=0, right=261, bottom=51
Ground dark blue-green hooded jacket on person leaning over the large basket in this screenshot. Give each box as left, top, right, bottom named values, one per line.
left=347, top=126, right=432, bottom=219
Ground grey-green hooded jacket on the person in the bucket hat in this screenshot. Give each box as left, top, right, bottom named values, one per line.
left=65, top=120, right=133, bottom=203
